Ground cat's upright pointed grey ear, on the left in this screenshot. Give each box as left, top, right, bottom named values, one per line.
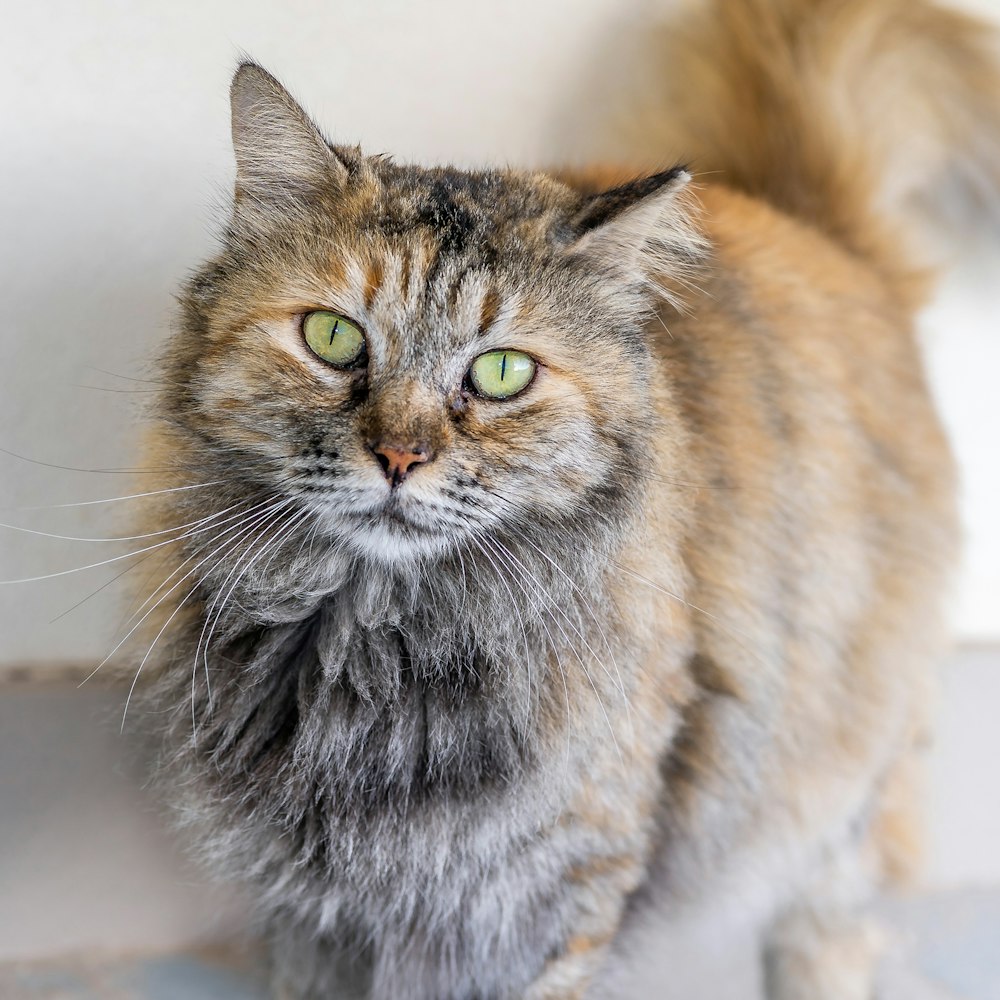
left=229, top=62, right=348, bottom=206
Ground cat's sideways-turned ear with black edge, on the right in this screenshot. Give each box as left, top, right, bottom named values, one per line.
left=566, top=167, right=704, bottom=274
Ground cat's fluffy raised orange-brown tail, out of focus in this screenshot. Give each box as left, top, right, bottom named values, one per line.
left=647, top=0, right=1000, bottom=304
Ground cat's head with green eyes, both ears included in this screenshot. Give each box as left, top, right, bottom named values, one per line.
left=162, top=64, right=701, bottom=567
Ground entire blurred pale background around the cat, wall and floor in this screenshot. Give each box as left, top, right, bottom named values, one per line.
left=0, top=0, right=1000, bottom=1000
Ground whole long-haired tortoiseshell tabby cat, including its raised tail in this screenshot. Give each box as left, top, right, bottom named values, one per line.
left=133, top=0, right=1000, bottom=1000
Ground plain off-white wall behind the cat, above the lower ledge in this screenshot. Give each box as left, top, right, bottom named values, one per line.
left=0, top=0, right=1000, bottom=665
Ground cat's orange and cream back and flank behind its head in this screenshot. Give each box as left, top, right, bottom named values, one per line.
left=636, top=187, right=956, bottom=908
